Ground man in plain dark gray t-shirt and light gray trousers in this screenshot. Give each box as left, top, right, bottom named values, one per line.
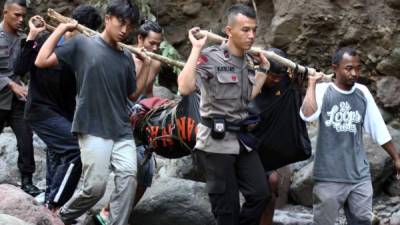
left=35, top=2, right=149, bottom=225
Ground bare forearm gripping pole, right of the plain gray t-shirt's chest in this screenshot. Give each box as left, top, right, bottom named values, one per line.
left=129, top=51, right=151, bottom=101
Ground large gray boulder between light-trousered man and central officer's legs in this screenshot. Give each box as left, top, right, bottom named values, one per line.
left=130, top=177, right=215, bottom=225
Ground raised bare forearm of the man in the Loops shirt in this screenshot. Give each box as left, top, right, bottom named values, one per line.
left=301, top=73, right=322, bottom=117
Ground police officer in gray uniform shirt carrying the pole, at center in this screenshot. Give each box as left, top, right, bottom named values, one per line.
left=178, top=4, right=270, bottom=225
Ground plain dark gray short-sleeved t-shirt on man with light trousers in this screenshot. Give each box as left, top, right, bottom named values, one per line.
left=55, top=35, right=136, bottom=140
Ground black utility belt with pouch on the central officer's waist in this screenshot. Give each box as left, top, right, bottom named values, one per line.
left=201, top=115, right=259, bottom=139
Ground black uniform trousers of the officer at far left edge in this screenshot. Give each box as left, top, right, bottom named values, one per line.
left=0, top=95, right=35, bottom=177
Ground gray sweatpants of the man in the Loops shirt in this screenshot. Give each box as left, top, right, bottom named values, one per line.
left=313, top=180, right=373, bottom=225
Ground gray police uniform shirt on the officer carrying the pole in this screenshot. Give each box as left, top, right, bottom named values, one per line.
left=195, top=43, right=255, bottom=154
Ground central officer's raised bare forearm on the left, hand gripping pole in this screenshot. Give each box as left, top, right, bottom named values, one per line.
left=178, top=27, right=207, bottom=95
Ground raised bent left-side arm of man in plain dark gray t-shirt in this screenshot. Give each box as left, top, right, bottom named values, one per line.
left=35, top=21, right=78, bottom=68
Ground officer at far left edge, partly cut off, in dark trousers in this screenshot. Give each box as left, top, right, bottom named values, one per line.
left=0, top=0, right=40, bottom=196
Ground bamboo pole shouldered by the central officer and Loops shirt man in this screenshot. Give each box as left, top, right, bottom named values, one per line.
left=195, top=30, right=333, bottom=81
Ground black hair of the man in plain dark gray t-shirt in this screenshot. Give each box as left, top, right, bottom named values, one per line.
left=106, top=0, right=140, bottom=25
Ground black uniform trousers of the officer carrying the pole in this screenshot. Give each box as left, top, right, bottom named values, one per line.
left=194, top=149, right=270, bottom=225
